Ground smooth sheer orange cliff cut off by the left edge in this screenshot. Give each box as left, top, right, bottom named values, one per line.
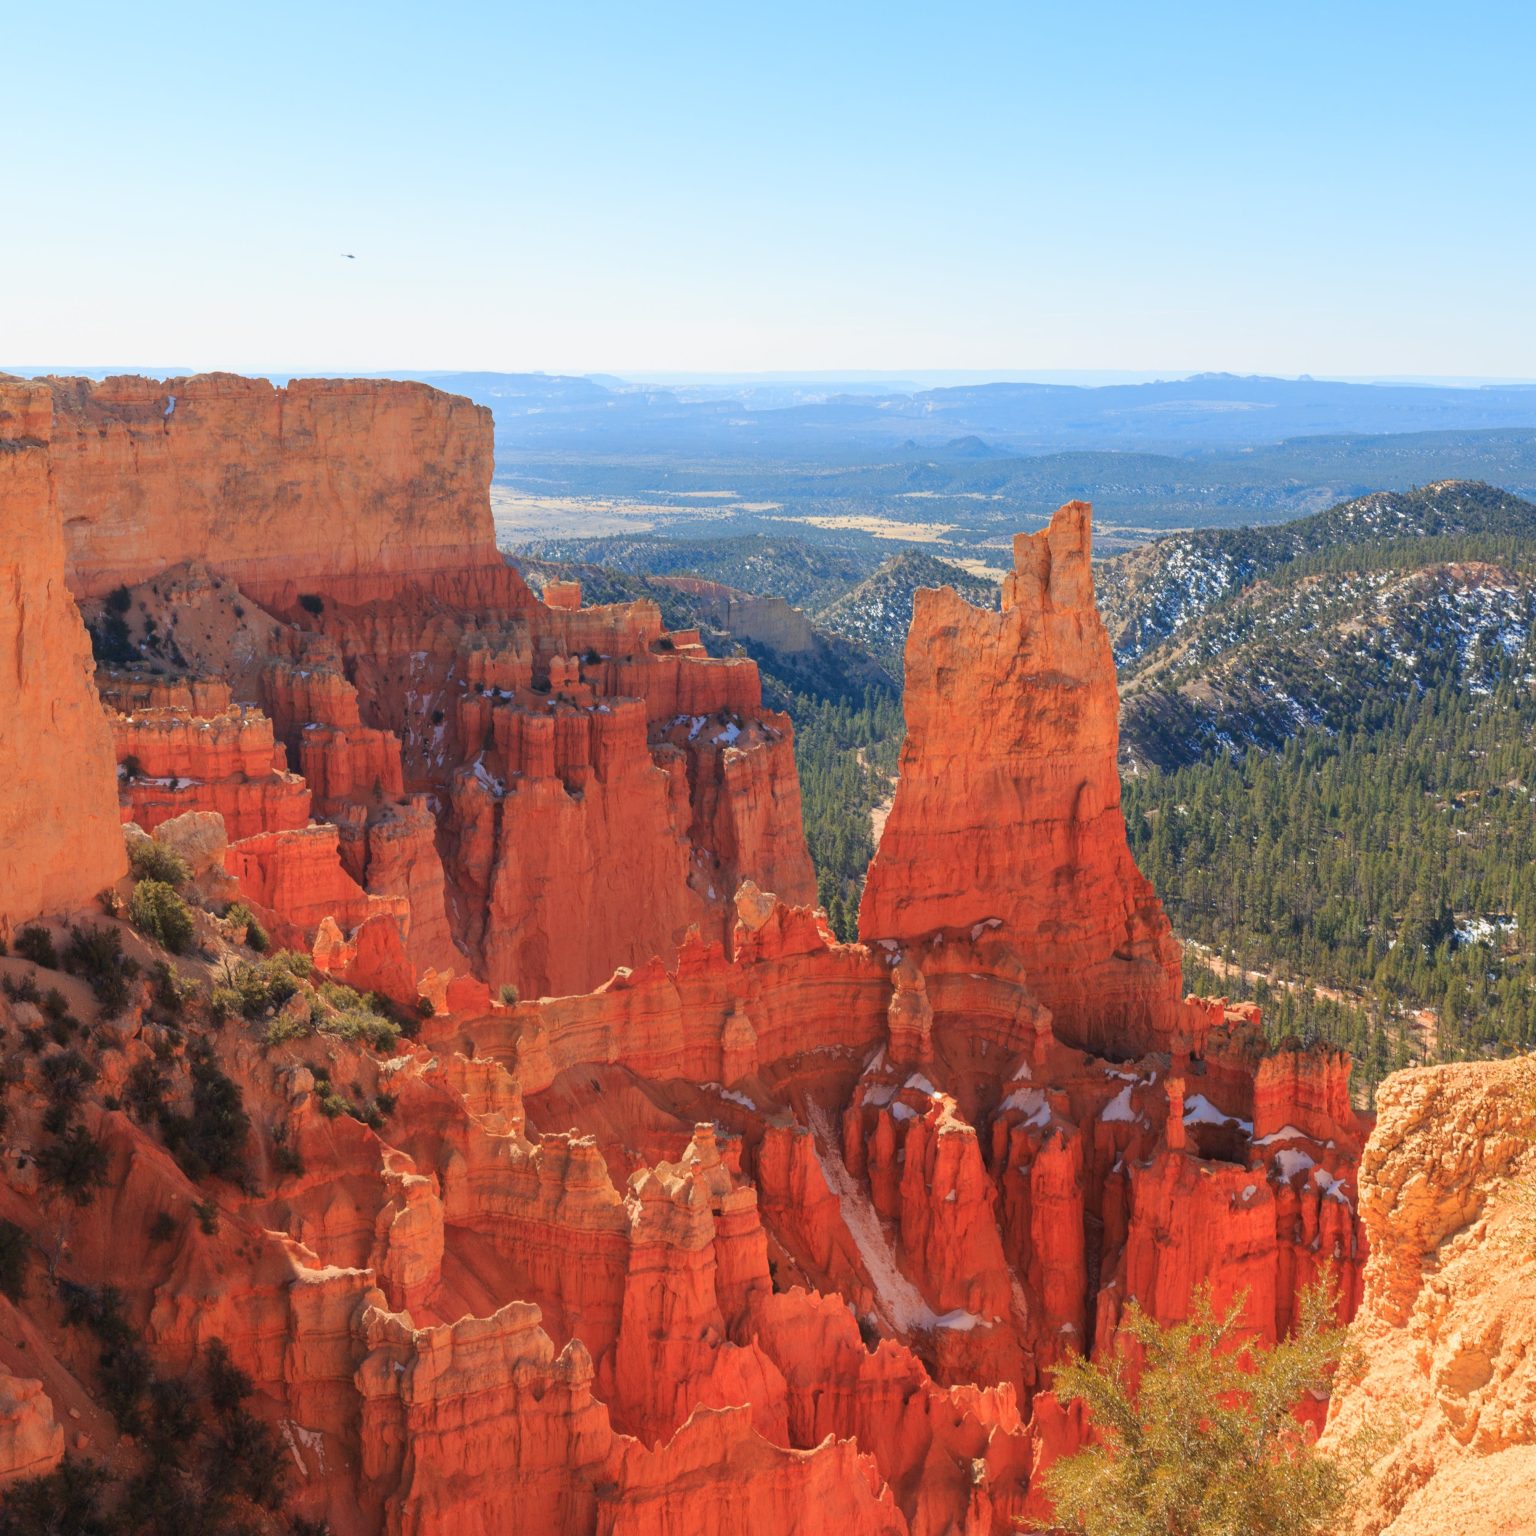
left=0, top=384, right=126, bottom=937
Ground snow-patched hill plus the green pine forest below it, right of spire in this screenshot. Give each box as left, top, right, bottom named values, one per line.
left=1098, top=482, right=1536, bottom=1087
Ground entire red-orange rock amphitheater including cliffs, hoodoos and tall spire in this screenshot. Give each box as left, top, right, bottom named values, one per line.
left=0, top=375, right=1367, bottom=1536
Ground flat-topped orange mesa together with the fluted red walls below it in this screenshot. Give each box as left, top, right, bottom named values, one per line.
left=24, top=375, right=814, bottom=992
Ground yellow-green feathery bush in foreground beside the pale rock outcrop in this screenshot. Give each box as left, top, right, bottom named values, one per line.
left=1046, top=1286, right=1350, bottom=1536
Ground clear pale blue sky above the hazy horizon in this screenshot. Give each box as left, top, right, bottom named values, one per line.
left=0, top=0, right=1536, bottom=378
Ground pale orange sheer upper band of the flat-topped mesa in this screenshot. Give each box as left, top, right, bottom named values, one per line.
left=31, top=373, right=499, bottom=608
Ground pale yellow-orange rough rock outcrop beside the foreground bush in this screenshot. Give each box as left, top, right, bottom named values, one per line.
left=1324, top=1057, right=1536, bottom=1536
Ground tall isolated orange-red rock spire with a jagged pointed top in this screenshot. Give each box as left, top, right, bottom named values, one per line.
left=859, top=501, right=1180, bottom=1051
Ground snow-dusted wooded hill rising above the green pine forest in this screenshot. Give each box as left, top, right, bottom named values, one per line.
left=1098, top=482, right=1536, bottom=768
